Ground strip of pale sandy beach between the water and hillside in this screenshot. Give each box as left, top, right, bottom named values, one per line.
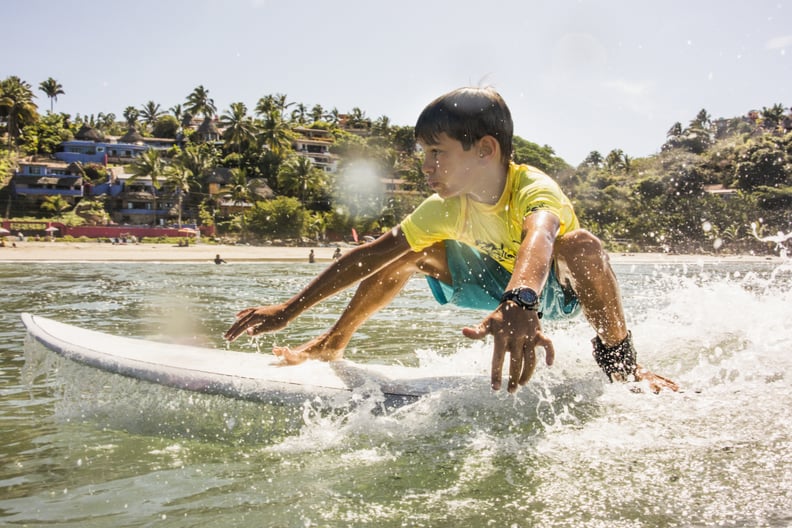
left=0, top=240, right=784, bottom=264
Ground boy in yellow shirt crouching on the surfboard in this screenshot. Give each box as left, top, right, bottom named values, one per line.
left=225, top=88, right=678, bottom=392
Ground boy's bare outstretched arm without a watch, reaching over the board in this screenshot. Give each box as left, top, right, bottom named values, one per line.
left=225, top=227, right=412, bottom=341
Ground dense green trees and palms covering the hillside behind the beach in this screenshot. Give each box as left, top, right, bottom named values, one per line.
left=0, top=77, right=792, bottom=252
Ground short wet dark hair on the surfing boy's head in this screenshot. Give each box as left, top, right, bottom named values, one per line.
left=415, top=88, right=514, bottom=165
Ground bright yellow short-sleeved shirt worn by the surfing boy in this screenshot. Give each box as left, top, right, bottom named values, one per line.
left=401, top=163, right=580, bottom=272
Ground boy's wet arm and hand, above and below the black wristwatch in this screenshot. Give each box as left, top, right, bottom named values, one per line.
left=462, top=211, right=560, bottom=392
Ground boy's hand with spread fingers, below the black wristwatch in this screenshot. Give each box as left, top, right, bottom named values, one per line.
left=462, top=302, right=555, bottom=393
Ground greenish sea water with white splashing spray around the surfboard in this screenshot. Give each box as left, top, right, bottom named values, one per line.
left=0, top=257, right=792, bottom=527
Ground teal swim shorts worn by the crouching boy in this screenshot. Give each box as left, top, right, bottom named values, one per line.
left=426, top=240, right=581, bottom=320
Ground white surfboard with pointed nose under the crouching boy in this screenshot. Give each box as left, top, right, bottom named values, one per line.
left=21, top=313, right=482, bottom=407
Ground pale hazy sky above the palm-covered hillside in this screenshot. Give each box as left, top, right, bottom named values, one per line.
left=6, top=0, right=792, bottom=165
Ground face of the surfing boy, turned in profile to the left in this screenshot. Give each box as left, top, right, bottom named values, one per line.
left=418, top=133, right=482, bottom=198
